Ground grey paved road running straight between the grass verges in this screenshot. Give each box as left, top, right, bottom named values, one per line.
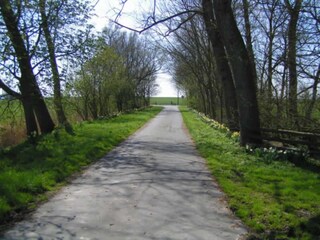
left=4, top=106, right=246, bottom=240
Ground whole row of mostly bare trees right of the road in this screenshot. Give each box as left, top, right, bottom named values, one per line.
left=140, top=0, right=320, bottom=145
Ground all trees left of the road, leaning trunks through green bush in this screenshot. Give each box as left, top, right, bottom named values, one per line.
left=0, top=0, right=159, bottom=139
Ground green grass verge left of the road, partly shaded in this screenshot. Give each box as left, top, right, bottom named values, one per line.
left=0, top=107, right=161, bottom=227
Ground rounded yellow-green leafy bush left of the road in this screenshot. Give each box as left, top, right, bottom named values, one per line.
left=69, top=47, right=127, bottom=120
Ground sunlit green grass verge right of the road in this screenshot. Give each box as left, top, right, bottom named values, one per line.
left=181, top=107, right=320, bottom=239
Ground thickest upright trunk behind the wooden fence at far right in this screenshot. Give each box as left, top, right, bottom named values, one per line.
left=286, top=0, right=302, bottom=127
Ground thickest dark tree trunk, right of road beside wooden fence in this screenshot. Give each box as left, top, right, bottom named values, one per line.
left=209, top=0, right=261, bottom=145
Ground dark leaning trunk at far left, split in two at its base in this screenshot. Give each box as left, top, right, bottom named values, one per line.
left=0, top=0, right=54, bottom=136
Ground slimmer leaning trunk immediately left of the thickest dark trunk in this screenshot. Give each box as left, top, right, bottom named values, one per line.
left=202, top=1, right=239, bottom=129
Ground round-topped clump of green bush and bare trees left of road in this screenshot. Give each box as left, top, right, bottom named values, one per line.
left=67, top=27, right=160, bottom=120
